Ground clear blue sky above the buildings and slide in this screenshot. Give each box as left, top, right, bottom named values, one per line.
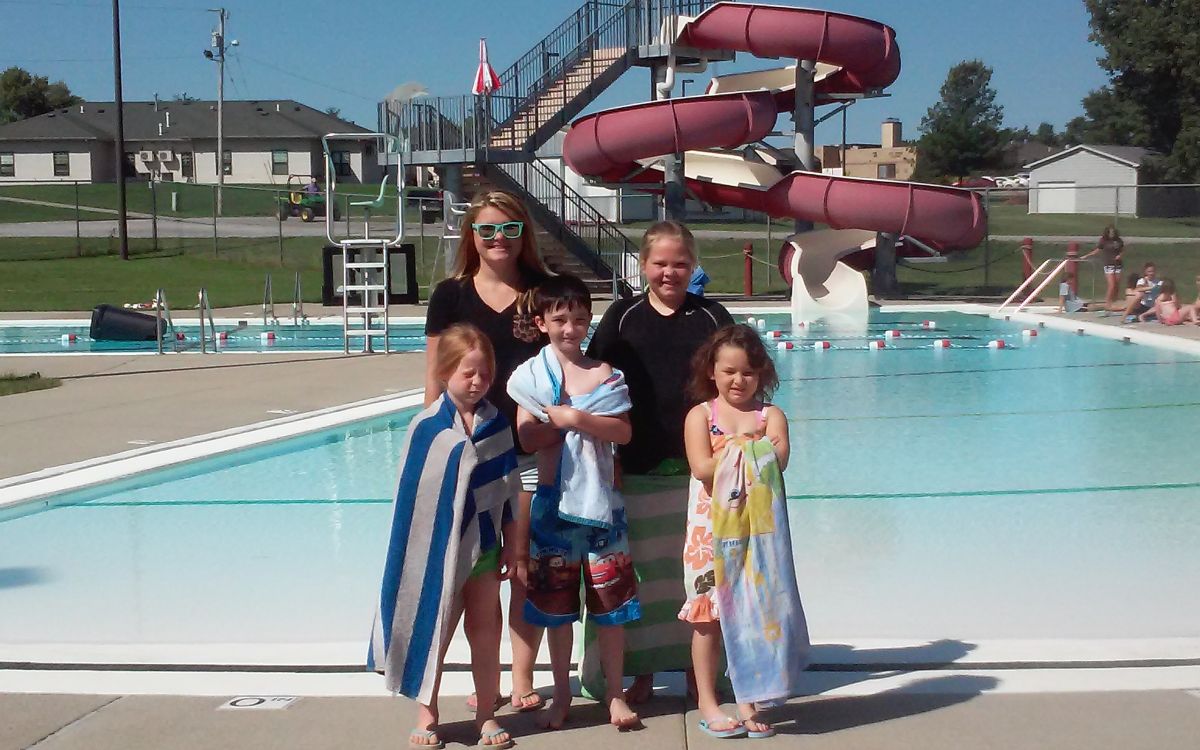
left=0, top=0, right=1105, bottom=143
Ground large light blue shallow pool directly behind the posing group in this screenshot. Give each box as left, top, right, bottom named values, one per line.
left=0, top=313, right=1200, bottom=665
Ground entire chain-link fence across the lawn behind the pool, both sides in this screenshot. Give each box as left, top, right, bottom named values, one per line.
left=0, top=182, right=1200, bottom=310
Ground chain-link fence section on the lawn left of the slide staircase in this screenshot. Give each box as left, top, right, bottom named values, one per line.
left=0, top=182, right=443, bottom=311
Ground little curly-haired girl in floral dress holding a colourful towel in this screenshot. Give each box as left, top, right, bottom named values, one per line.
left=679, top=325, right=809, bottom=739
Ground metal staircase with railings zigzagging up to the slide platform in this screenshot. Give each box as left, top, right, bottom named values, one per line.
left=379, top=0, right=732, bottom=294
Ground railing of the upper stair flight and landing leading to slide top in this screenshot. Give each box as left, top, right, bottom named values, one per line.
left=379, top=0, right=713, bottom=161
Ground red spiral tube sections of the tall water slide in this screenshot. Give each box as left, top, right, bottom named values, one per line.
left=563, top=2, right=986, bottom=250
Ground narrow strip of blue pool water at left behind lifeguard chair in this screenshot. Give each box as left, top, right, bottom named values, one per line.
left=0, top=319, right=425, bottom=356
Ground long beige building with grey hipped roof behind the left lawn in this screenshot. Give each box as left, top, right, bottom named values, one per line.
left=0, top=100, right=383, bottom=185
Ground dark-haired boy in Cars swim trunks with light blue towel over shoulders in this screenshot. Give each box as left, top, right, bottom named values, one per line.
left=508, top=275, right=641, bottom=730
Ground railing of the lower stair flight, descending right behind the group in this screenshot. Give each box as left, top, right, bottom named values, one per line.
left=492, top=160, right=638, bottom=299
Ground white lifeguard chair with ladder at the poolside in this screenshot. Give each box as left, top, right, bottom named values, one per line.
left=322, top=133, right=404, bottom=354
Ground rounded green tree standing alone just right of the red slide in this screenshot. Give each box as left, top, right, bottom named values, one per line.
left=914, top=60, right=1006, bottom=180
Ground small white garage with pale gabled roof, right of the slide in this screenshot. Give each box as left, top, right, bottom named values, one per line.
left=1025, top=144, right=1153, bottom=215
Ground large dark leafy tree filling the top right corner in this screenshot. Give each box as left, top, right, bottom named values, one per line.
left=1076, top=0, right=1200, bottom=181
